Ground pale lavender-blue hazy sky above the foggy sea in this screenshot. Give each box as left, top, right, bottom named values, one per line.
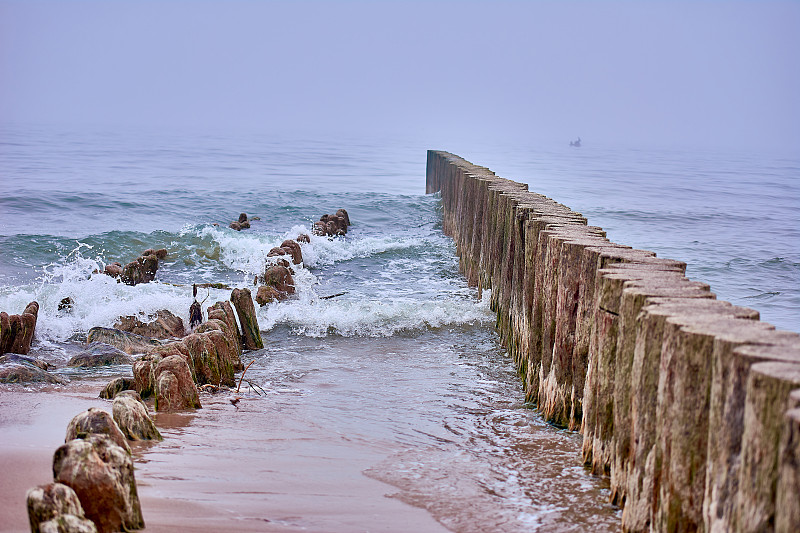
left=0, top=0, right=800, bottom=154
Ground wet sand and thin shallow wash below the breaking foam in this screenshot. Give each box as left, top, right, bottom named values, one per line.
left=0, top=328, right=619, bottom=533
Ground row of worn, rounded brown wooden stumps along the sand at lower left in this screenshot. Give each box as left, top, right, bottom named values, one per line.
left=21, top=289, right=263, bottom=532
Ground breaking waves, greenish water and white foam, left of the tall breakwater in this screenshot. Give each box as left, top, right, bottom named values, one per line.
left=0, top=219, right=492, bottom=347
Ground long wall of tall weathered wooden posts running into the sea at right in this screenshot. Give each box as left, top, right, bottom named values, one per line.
left=426, top=150, right=800, bottom=532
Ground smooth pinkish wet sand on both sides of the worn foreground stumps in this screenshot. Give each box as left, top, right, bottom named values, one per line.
left=0, top=381, right=447, bottom=532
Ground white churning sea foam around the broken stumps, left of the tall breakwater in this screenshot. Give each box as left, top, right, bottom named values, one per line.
left=0, top=230, right=492, bottom=346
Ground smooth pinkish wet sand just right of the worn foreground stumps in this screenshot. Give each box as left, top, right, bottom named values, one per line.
left=134, top=392, right=454, bottom=532
